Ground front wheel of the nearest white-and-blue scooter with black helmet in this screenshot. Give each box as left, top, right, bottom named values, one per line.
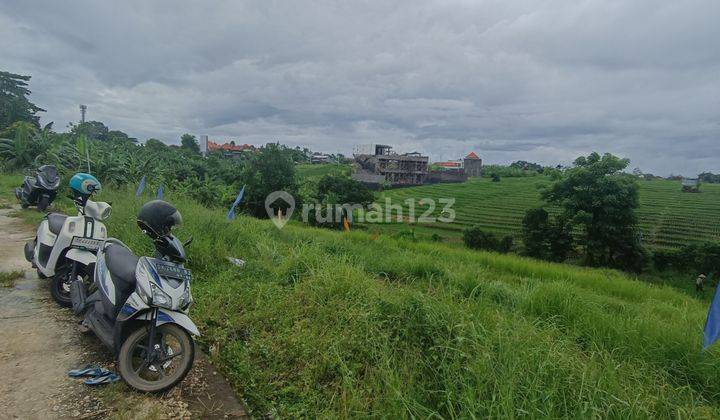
left=118, top=324, right=195, bottom=392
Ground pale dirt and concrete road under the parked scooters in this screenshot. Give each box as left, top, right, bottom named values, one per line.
left=0, top=209, right=245, bottom=419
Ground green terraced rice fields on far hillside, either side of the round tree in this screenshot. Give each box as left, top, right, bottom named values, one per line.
left=368, top=177, right=720, bottom=248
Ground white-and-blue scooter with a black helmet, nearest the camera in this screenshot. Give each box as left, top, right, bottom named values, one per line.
left=71, top=200, right=200, bottom=392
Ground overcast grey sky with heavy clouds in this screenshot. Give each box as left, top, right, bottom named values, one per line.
left=0, top=0, right=720, bottom=175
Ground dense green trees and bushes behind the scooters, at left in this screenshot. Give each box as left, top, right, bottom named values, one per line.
left=0, top=72, right=372, bottom=217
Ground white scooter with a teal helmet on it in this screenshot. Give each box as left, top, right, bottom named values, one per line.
left=25, top=173, right=112, bottom=307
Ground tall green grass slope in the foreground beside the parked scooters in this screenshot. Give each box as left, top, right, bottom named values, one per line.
left=2, top=171, right=720, bottom=418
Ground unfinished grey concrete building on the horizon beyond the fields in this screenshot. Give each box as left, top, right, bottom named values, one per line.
left=352, top=144, right=428, bottom=186
